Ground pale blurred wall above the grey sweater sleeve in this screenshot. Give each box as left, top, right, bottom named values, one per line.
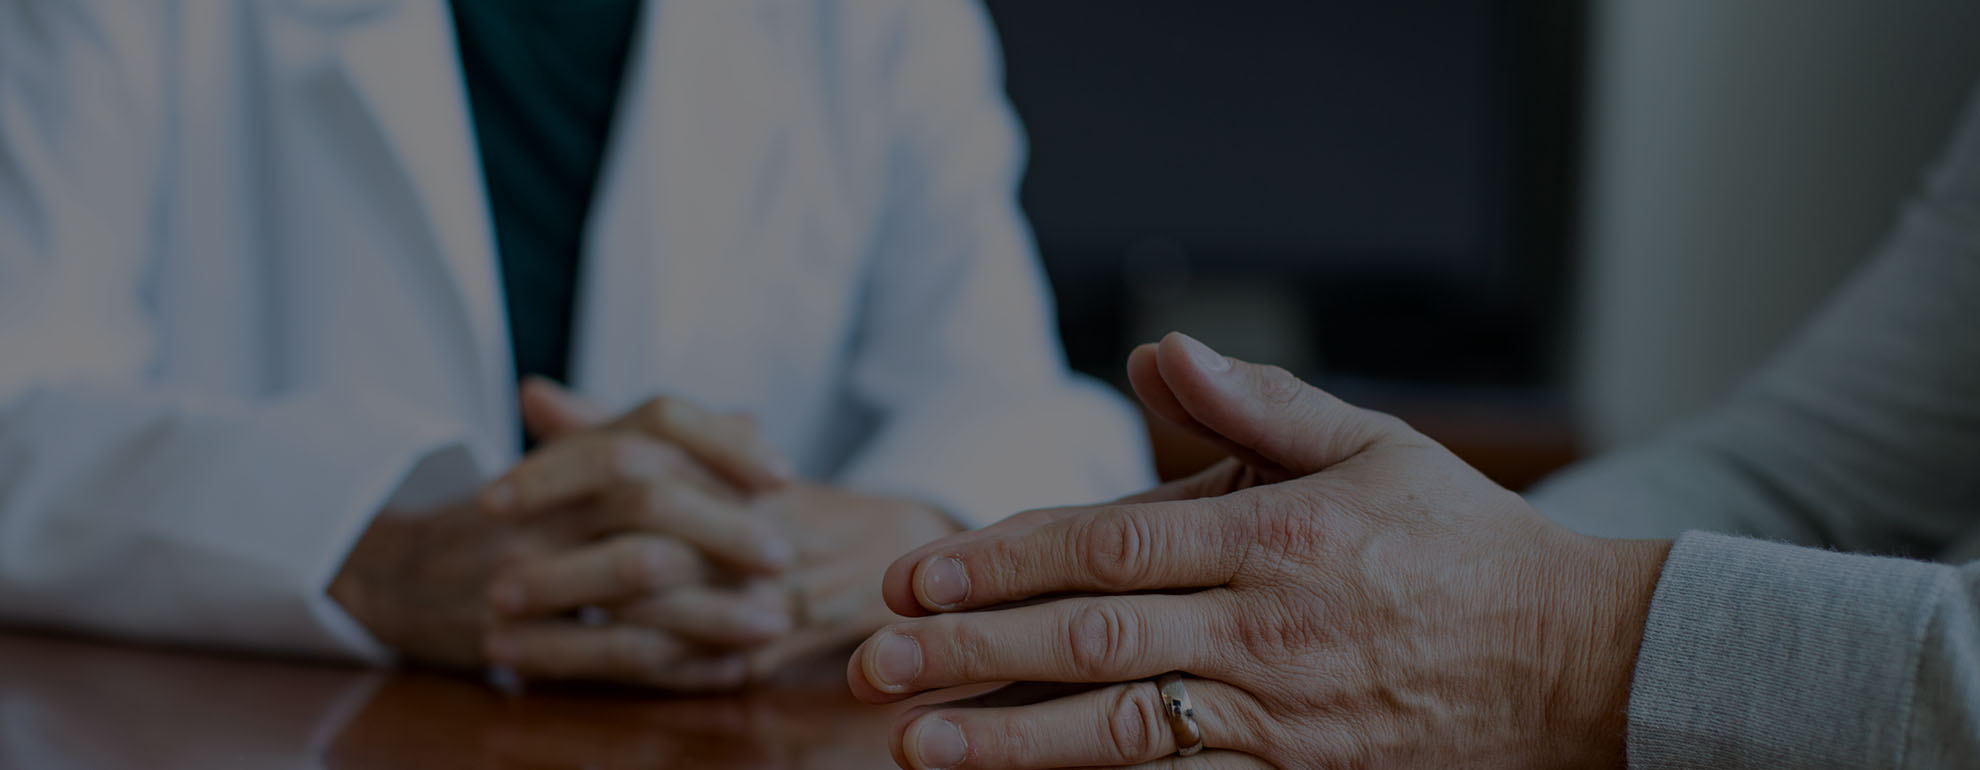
left=1574, top=0, right=1980, bottom=447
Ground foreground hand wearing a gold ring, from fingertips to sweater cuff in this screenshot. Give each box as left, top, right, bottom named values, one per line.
left=847, top=335, right=1669, bottom=770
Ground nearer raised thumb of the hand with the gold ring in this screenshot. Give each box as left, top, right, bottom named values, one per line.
left=1135, top=333, right=1408, bottom=479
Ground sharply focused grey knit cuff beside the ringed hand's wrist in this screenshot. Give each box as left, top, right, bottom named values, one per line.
left=1628, top=532, right=1944, bottom=770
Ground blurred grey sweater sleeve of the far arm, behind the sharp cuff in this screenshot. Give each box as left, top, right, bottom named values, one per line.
left=1531, top=79, right=1980, bottom=558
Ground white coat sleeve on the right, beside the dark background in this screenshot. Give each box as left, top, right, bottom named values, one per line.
left=840, top=0, right=1150, bottom=525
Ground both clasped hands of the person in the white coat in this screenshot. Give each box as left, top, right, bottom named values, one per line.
left=331, top=380, right=952, bottom=691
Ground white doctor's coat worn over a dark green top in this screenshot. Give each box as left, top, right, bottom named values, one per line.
left=0, top=0, right=1146, bottom=657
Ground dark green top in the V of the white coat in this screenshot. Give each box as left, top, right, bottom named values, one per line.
left=451, top=0, right=642, bottom=395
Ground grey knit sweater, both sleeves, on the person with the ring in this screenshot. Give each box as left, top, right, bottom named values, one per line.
left=1531, top=82, right=1980, bottom=770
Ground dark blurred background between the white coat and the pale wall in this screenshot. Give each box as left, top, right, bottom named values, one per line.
left=988, top=0, right=1586, bottom=485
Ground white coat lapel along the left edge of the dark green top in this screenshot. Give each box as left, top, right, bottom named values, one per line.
left=297, top=0, right=517, bottom=455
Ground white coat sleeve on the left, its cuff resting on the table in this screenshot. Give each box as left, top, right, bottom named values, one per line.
left=0, top=0, right=465, bottom=659
